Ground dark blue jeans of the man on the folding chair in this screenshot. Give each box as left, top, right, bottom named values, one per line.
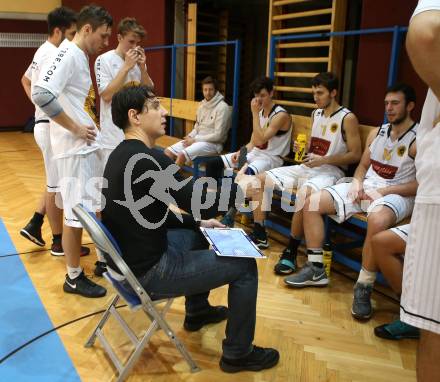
left=139, top=229, right=258, bottom=359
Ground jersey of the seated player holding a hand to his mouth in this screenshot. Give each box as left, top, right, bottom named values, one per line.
left=254, top=105, right=292, bottom=156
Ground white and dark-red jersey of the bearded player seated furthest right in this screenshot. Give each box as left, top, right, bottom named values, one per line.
left=364, top=123, right=418, bottom=189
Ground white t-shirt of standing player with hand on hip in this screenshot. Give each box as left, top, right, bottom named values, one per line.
left=35, top=39, right=101, bottom=158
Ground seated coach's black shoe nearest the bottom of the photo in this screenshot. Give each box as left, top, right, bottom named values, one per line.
left=220, top=346, right=280, bottom=373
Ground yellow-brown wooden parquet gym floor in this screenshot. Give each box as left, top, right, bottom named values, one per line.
left=0, top=132, right=416, bottom=382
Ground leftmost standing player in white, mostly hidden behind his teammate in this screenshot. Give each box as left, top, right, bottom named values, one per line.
left=20, top=7, right=78, bottom=255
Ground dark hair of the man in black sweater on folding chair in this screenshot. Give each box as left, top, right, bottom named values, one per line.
left=112, top=86, right=156, bottom=130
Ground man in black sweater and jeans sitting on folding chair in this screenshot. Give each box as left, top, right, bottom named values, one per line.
left=102, top=86, right=279, bottom=372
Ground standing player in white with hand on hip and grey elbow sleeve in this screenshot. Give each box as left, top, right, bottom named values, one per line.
left=32, top=5, right=113, bottom=297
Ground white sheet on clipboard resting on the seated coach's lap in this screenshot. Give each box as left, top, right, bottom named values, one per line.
left=200, top=227, right=266, bottom=259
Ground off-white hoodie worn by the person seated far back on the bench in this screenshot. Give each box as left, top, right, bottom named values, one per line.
left=188, top=92, right=231, bottom=144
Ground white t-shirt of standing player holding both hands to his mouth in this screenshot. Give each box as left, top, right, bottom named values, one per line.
left=95, top=50, right=141, bottom=149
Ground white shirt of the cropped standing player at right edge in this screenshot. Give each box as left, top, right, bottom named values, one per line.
left=412, top=0, right=440, bottom=204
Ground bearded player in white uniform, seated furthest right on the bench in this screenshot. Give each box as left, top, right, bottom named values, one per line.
left=285, top=84, right=417, bottom=300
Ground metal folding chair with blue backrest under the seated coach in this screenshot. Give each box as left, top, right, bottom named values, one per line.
left=73, top=204, right=200, bottom=381
